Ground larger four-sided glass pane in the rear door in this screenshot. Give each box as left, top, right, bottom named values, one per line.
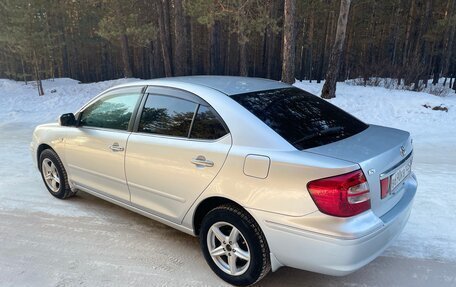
left=138, top=95, right=198, bottom=137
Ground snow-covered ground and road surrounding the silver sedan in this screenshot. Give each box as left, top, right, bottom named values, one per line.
left=0, top=79, right=456, bottom=286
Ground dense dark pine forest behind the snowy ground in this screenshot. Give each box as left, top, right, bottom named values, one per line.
left=0, top=0, right=456, bottom=94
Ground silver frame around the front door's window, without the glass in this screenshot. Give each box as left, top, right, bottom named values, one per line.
left=76, top=86, right=147, bottom=133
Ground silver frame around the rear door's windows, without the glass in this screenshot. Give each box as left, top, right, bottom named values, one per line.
left=132, top=86, right=231, bottom=142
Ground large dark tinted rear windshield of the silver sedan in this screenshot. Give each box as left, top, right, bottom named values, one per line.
left=231, top=88, right=368, bottom=150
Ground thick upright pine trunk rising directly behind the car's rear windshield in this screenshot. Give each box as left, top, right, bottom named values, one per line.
left=282, top=0, right=296, bottom=84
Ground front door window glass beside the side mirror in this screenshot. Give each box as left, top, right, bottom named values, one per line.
left=79, top=93, right=140, bottom=131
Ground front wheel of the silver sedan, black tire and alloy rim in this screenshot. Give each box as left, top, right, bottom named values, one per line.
left=39, top=149, right=76, bottom=199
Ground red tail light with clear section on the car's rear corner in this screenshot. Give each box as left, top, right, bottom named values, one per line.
left=307, top=169, right=371, bottom=217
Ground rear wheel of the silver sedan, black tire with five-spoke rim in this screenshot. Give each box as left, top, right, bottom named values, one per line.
left=199, top=205, right=271, bottom=286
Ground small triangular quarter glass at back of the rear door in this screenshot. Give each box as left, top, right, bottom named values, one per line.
left=190, top=105, right=227, bottom=140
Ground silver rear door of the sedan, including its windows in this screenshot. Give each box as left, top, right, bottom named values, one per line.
left=125, top=88, right=231, bottom=223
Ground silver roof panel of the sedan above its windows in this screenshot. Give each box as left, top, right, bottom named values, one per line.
left=116, top=76, right=290, bottom=96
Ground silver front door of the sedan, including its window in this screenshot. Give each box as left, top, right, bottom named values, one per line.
left=65, top=87, right=142, bottom=203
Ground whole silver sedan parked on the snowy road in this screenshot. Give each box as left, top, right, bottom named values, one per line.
left=31, top=76, right=417, bottom=286
